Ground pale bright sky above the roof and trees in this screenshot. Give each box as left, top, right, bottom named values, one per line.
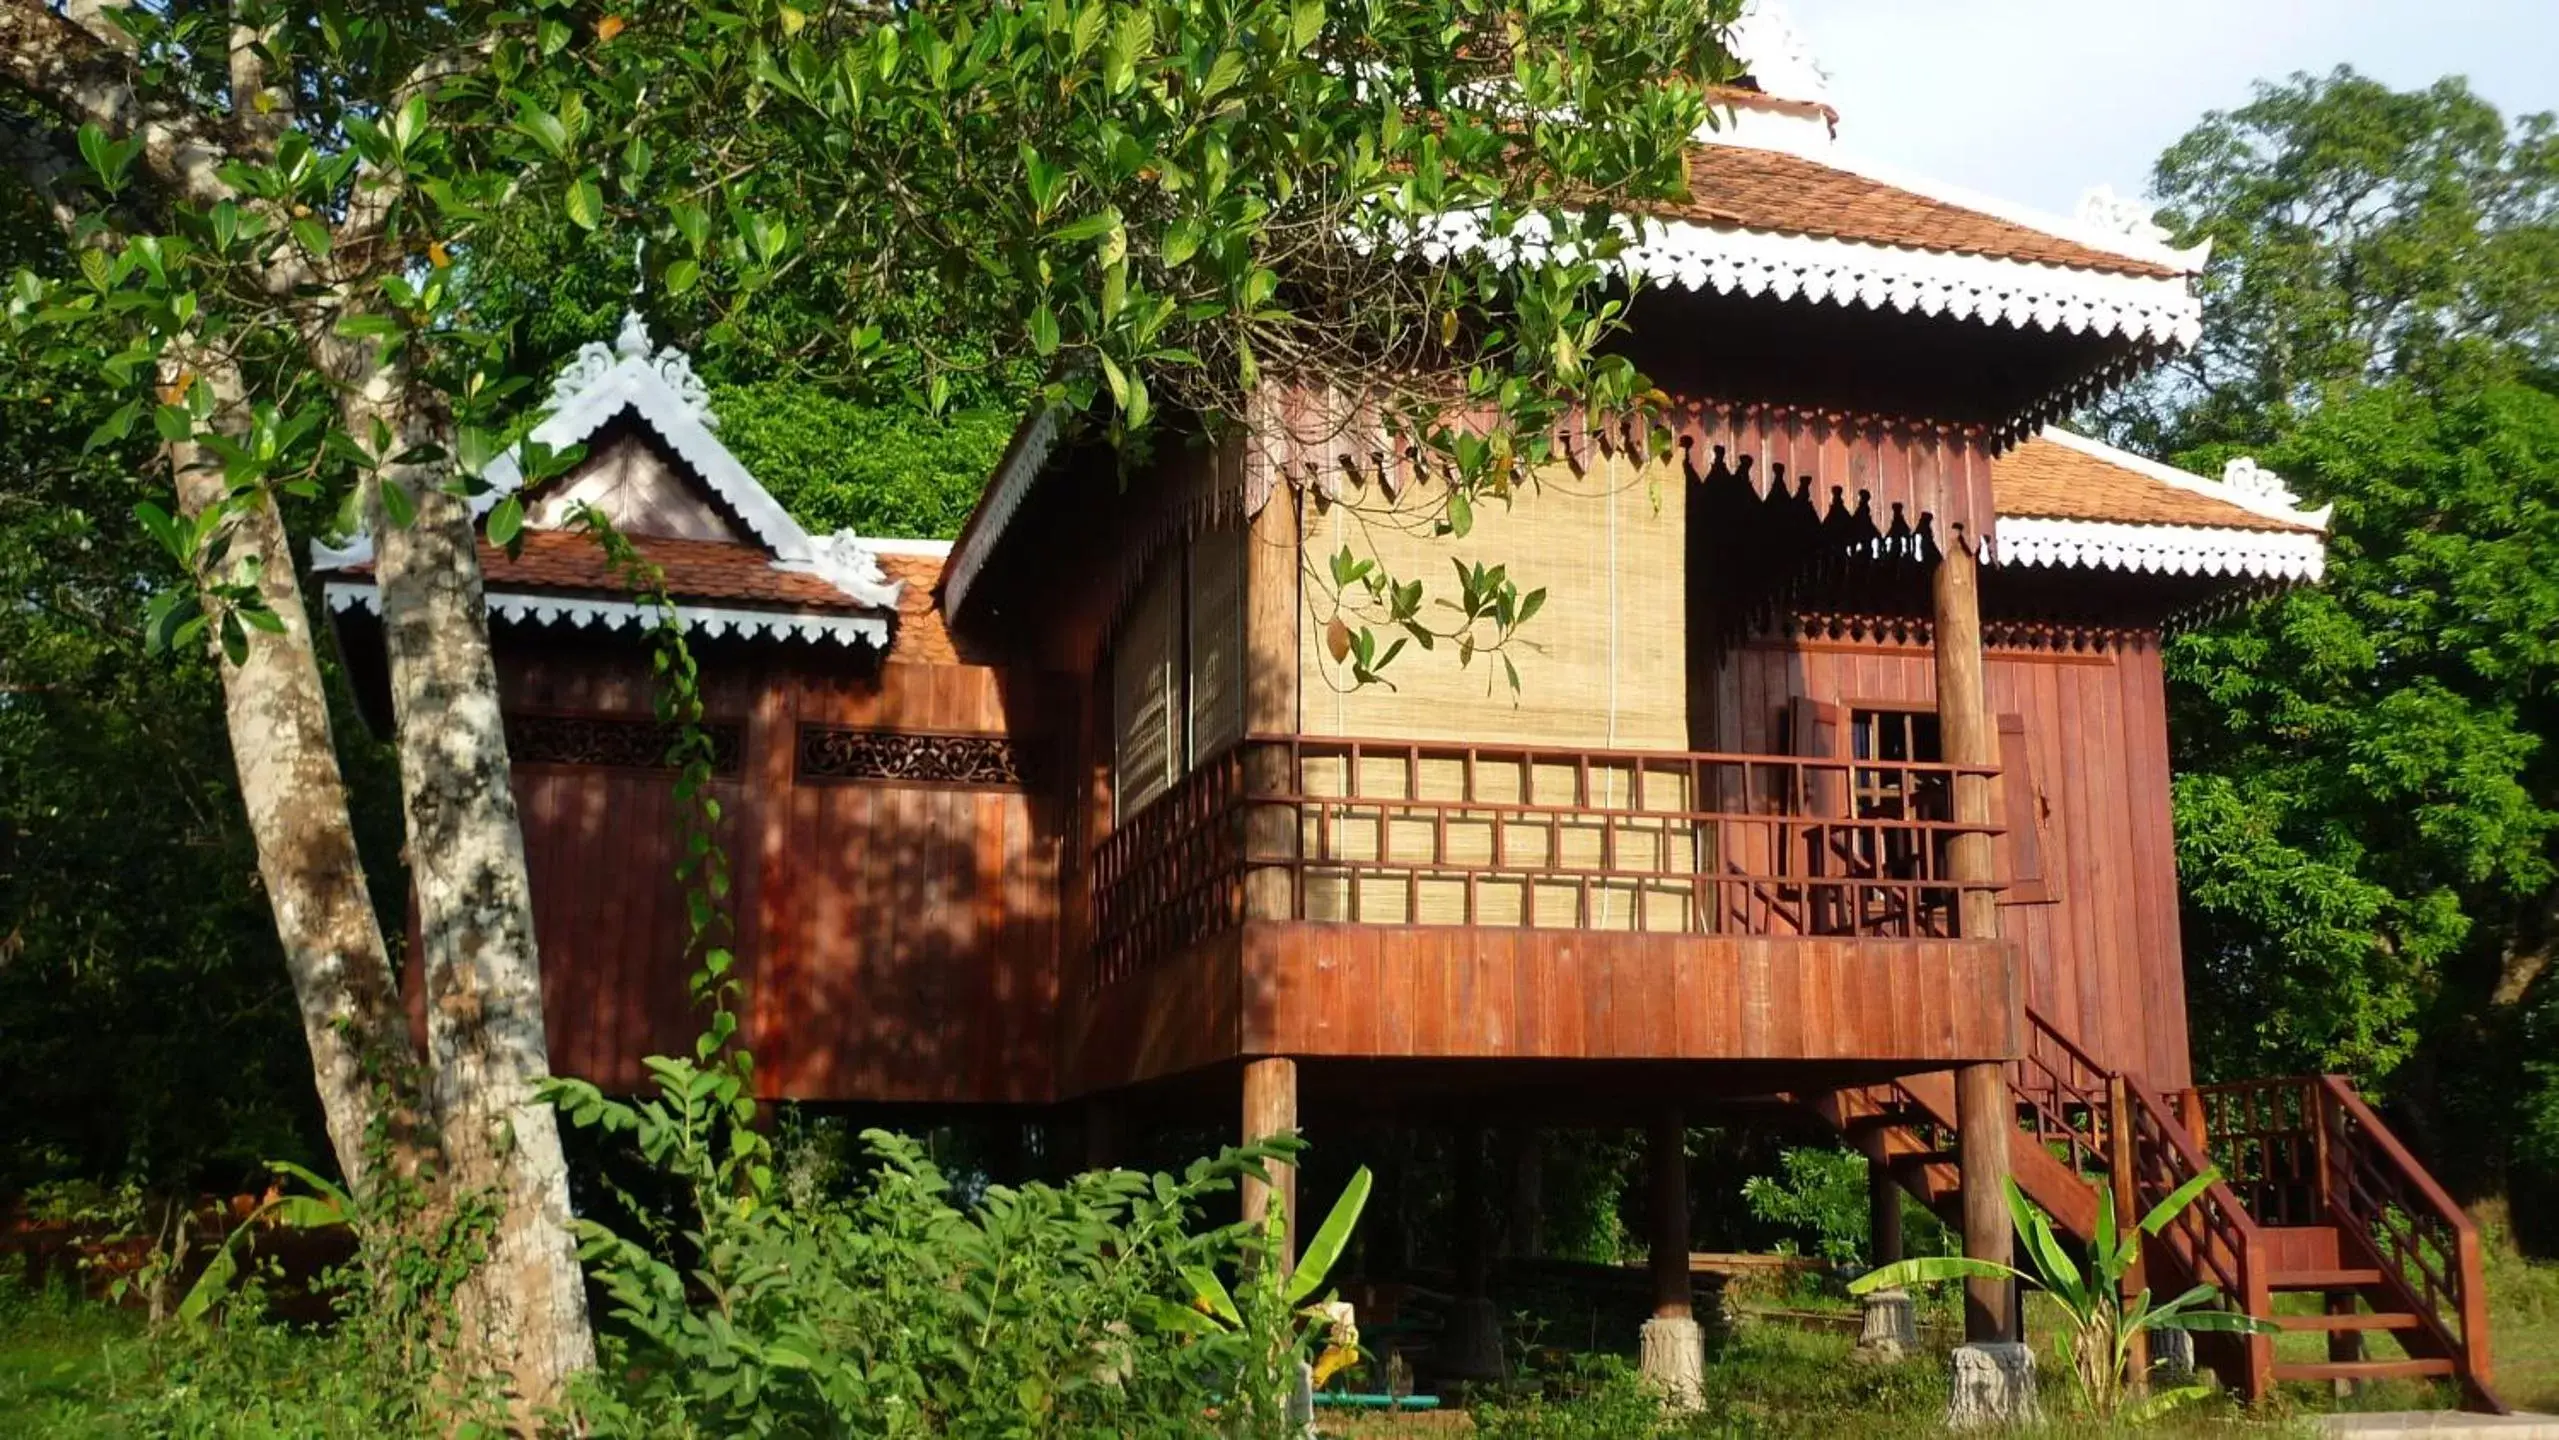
left=1786, top=0, right=2559, bottom=215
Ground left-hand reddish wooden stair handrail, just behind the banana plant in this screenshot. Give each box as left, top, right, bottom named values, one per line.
left=2124, top=1074, right=2275, bottom=1402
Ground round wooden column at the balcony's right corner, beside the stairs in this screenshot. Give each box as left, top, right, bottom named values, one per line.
left=1929, top=535, right=2016, bottom=1343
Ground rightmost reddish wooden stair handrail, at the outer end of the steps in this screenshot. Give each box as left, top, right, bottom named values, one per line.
left=2318, top=1074, right=2503, bottom=1409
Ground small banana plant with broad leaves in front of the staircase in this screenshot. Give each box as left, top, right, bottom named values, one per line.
left=1848, top=1169, right=2272, bottom=1422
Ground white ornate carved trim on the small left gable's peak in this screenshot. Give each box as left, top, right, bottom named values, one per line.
left=312, top=312, right=903, bottom=609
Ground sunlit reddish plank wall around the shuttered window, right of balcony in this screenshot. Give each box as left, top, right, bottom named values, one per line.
left=1699, top=637, right=2191, bottom=1087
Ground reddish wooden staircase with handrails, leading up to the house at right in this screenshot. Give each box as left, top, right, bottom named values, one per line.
left=1814, top=1010, right=2505, bottom=1414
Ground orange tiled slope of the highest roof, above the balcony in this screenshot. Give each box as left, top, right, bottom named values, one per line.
left=1668, top=146, right=2178, bottom=276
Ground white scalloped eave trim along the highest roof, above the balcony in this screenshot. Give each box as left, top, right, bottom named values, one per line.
left=1420, top=215, right=2203, bottom=348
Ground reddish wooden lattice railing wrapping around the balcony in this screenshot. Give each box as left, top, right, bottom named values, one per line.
left=1093, top=737, right=1996, bottom=985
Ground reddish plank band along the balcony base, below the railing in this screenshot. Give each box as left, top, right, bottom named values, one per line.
left=1067, top=921, right=2024, bottom=1092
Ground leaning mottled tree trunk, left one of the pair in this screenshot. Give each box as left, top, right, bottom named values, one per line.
left=164, top=348, right=417, bottom=1194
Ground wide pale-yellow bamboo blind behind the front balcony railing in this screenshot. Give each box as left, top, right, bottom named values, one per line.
left=1300, top=460, right=1707, bottom=931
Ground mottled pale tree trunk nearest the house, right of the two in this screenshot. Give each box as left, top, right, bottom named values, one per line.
left=345, top=366, right=596, bottom=1422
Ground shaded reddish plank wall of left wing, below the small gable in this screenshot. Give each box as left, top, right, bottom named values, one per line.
left=499, top=637, right=1059, bottom=1102
